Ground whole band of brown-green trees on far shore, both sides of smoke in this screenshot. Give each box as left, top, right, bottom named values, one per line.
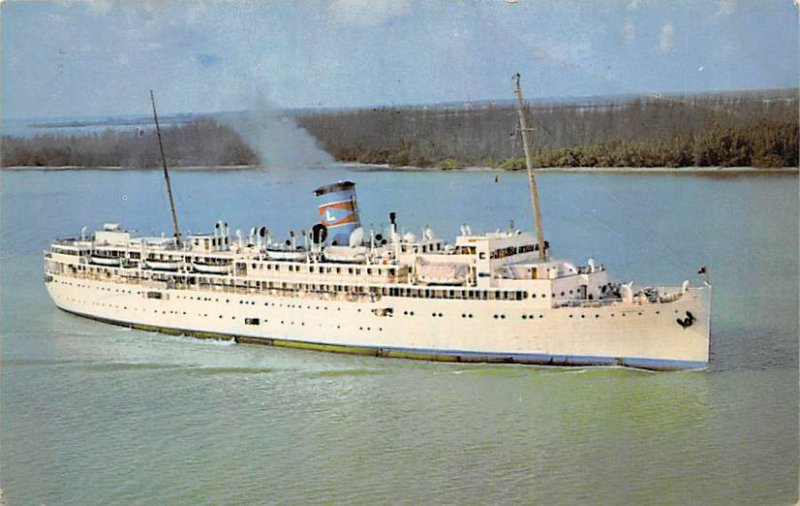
left=2, top=90, right=799, bottom=170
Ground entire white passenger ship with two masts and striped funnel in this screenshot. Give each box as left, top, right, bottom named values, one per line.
left=44, top=79, right=712, bottom=370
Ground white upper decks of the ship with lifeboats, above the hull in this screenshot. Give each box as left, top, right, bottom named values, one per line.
left=46, top=213, right=688, bottom=307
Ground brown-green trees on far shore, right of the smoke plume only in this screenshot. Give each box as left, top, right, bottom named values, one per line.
left=298, top=90, right=798, bottom=170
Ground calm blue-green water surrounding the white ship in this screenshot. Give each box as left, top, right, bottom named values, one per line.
left=0, top=167, right=798, bottom=505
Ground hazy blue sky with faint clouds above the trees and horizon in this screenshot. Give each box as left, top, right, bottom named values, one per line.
left=0, top=0, right=798, bottom=118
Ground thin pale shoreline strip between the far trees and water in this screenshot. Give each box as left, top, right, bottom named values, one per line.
left=0, top=162, right=800, bottom=174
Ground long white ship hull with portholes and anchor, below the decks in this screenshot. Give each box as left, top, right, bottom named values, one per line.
left=47, top=275, right=711, bottom=370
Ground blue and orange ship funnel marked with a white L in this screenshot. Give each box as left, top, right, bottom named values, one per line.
left=314, top=181, right=361, bottom=245
